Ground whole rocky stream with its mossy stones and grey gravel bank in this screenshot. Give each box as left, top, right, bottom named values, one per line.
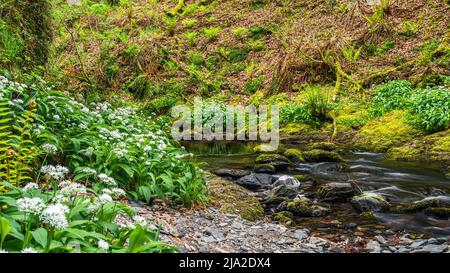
left=155, top=140, right=450, bottom=253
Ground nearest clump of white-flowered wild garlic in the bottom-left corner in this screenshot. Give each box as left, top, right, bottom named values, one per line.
left=0, top=181, right=177, bottom=253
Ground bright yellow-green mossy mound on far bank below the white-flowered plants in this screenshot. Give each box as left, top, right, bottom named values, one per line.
left=354, top=110, right=421, bottom=152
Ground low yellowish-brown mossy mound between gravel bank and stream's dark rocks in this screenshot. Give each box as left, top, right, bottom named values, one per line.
left=207, top=175, right=264, bottom=221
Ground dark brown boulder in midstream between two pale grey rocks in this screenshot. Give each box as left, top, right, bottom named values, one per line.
left=317, top=182, right=357, bottom=202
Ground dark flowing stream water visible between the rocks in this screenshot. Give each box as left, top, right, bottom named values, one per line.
left=181, top=142, right=450, bottom=236
